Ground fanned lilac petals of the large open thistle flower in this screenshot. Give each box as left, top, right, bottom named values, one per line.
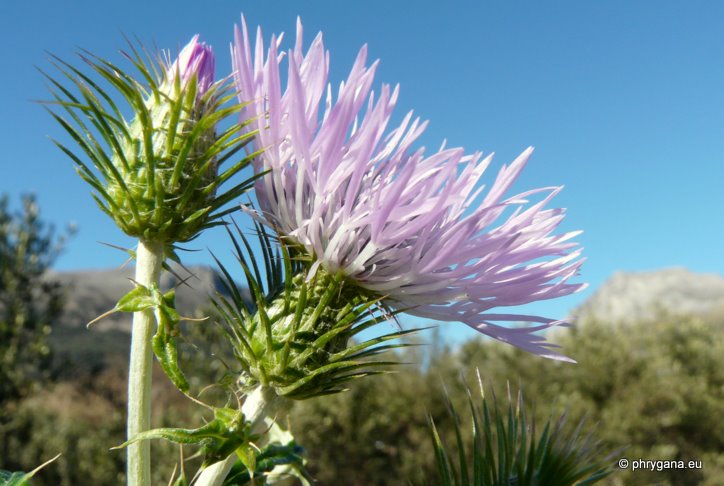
left=233, top=18, right=585, bottom=360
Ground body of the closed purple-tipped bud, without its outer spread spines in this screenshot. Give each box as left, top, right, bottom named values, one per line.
left=103, top=36, right=216, bottom=243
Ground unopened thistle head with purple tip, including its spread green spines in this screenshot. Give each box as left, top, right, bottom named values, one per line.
left=50, top=35, right=258, bottom=246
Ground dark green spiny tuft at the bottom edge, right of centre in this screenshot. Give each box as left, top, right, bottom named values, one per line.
left=428, top=376, right=611, bottom=486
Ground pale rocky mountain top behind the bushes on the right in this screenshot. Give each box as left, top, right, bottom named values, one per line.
left=574, top=268, right=724, bottom=323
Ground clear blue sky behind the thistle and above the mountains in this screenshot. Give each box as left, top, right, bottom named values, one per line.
left=0, top=0, right=724, bottom=342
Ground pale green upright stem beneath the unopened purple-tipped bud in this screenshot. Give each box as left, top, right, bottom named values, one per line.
left=126, top=240, right=163, bottom=486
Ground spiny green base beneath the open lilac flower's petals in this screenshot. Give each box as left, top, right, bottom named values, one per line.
left=214, top=224, right=417, bottom=400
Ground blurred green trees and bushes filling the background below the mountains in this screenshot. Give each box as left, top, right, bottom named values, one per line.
left=0, top=199, right=724, bottom=486
